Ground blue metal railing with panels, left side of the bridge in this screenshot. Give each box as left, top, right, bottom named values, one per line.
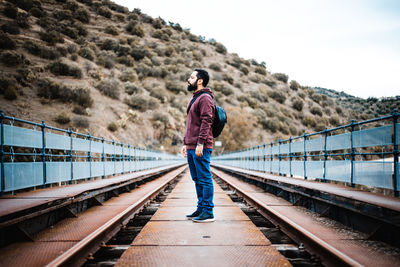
left=0, top=111, right=184, bottom=193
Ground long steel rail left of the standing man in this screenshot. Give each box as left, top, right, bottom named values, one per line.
left=46, top=166, right=186, bottom=267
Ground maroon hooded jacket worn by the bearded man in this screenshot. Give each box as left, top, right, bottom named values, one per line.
left=183, top=88, right=215, bottom=149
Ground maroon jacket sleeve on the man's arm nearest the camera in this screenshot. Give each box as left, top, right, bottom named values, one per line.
left=197, top=94, right=215, bottom=144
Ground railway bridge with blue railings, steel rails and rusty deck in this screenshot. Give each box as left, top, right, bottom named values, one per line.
left=0, top=111, right=400, bottom=266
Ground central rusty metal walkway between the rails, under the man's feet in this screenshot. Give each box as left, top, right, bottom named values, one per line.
left=115, top=174, right=291, bottom=266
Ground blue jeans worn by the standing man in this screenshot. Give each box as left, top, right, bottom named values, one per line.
left=187, top=148, right=214, bottom=214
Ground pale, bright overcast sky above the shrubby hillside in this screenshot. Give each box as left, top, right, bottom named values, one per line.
left=114, top=0, right=400, bottom=98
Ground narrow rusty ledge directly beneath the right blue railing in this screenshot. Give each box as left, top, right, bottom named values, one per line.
left=213, top=164, right=400, bottom=211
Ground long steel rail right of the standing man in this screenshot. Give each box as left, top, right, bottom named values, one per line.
left=212, top=169, right=363, bottom=266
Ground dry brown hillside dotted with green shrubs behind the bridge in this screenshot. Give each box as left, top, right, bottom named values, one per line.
left=0, top=0, right=391, bottom=152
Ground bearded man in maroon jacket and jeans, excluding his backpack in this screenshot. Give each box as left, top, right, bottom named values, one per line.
left=181, top=69, right=215, bottom=222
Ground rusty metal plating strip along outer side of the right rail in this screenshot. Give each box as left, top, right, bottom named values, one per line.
left=215, top=168, right=400, bottom=266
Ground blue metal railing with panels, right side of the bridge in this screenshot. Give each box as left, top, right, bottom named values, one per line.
left=212, top=110, right=400, bottom=196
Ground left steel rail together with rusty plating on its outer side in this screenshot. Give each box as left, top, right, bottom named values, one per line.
left=0, top=166, right=187, bottom=266
